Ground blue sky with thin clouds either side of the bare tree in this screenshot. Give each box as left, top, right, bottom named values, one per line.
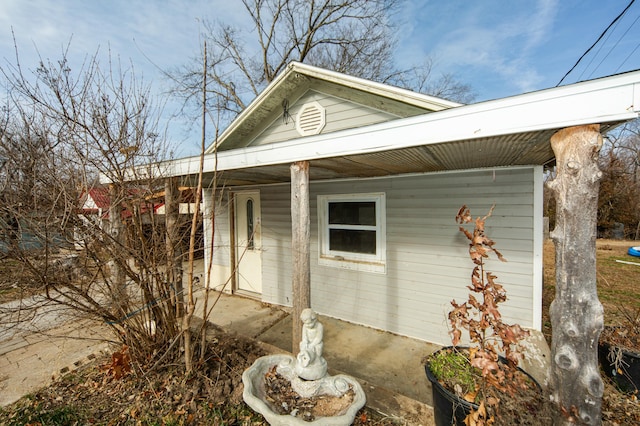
left=0, top=0, right=640, bottom=155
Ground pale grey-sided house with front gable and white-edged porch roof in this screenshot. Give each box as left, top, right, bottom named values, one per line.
left=134, top=63, right=640, bottom=343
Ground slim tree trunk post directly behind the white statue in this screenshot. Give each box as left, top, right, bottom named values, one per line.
left=291, top=161, right=311, bottom=354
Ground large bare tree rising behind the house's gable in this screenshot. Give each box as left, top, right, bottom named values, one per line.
left=170, top=0, right=473, bottom=128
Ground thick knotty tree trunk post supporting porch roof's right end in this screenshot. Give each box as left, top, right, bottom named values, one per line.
left=547, top=125, right=604, bottom=425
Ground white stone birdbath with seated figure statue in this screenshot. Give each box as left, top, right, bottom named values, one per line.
left=242, top=309, right=366, bottom=426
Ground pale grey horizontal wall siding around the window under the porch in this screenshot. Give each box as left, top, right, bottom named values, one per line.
left=254, top=167, right=541, bottom=344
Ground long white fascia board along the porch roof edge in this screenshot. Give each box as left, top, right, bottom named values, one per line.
left=166, top=71, right=640, bottom=176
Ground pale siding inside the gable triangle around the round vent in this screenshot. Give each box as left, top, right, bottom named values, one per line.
left=250, top=91, right=397, bottom=146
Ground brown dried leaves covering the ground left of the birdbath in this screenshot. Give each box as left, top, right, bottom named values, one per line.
left=0, top=329, right=398, bottom=426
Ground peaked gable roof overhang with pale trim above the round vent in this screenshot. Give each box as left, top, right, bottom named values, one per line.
left=205, top=62, right=461, bottom=153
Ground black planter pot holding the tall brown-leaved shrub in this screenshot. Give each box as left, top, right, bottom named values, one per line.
left=424, top=346, right=542, bottom=426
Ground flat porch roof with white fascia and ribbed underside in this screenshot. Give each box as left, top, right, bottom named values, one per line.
left=155, top=71, right=640, bottom=186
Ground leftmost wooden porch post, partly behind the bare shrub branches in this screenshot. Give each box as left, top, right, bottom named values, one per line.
left=164, top=177, right=184, bottom=318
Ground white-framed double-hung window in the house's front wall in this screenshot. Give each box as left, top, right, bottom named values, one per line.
left=318, top=193, right=386, bottom=273
